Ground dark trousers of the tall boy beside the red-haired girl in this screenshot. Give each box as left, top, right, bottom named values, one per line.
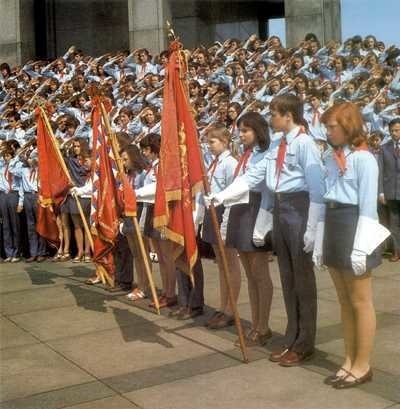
left=273, top=192, right=317, bottom=353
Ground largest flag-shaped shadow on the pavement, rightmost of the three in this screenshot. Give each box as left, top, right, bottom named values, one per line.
left=109, top=306, right=174, bottom=348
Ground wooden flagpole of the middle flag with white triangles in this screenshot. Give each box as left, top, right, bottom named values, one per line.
left=100, top=102, right=160, bottom=315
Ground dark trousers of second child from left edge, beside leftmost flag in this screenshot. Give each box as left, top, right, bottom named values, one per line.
left=24, top=192, right=46, bottom=257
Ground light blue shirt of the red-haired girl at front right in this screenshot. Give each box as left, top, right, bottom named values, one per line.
left=324, top=146, right=379, bottom=220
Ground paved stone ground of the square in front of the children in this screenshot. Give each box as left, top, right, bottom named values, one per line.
left=0, top=261, right=400, bottom=409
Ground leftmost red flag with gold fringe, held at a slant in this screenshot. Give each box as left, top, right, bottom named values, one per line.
left=35, top=108, right=72, bottom=246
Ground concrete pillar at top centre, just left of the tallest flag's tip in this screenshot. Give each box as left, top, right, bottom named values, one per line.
left=128, top=0, right=172, bottom=53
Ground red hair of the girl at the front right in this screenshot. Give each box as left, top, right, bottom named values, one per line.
left=321, top=102, right=367, bottom=148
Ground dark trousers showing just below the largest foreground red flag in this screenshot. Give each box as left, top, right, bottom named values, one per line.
left=176, top=257, right=204, bottom=310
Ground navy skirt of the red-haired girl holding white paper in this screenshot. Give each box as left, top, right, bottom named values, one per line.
left=323, top=205, right=382, bottom=274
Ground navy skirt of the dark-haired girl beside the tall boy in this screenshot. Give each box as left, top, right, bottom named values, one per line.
left=225, top=192, right=272, bottom=252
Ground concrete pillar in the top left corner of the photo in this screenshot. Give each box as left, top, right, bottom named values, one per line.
left=0, top=0, right=35, bottom=66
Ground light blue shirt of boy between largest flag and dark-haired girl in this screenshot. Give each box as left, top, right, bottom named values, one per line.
left=207, top=150, right=238, bottom=193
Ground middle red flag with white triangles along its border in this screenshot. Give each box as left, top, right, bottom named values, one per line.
left=91, top=97, right=136, bottom=276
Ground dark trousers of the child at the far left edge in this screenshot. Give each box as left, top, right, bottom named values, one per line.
left=0, top=191, right=21, bottom=257
